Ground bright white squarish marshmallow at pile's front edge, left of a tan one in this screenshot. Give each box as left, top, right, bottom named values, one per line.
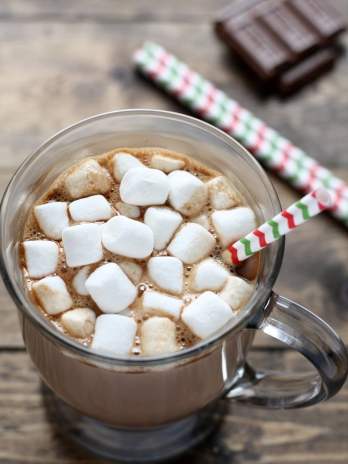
left=91, top=314, right=137, bottom=356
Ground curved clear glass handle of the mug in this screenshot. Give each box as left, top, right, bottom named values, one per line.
left=226, top=293, right=348, bottom=409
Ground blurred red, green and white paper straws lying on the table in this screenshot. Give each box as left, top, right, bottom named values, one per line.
left=134, top=42, right=348, bottom=226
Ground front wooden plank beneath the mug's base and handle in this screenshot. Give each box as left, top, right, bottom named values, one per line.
left=0, top=352, right=348, bottom=464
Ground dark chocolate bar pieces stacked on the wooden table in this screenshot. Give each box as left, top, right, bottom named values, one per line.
left=215, top=0, right=345, bottom=93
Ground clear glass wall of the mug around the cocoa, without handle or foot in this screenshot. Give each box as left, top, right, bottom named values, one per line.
left=1, top=110, right=281, bottom=427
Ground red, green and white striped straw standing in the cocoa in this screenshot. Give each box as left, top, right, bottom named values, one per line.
left=223, top=188, right=333, bottom=266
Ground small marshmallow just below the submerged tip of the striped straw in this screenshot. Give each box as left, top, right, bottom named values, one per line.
left=191, top=258, right=230, bottom=292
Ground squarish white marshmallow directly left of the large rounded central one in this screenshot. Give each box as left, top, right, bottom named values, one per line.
left=62, top=224, right=103, bottom=267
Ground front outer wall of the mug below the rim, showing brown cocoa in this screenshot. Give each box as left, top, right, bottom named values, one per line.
left=22, top=317, right=250, bottom=428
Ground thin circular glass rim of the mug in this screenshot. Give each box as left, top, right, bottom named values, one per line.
left=0, top=109, right=285, bottom=367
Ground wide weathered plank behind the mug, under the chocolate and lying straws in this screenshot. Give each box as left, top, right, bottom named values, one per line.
left=0, top=20, right=348, bottom=168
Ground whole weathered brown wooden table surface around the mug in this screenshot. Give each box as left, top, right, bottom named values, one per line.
left=0, top=0, right=348, bottom=464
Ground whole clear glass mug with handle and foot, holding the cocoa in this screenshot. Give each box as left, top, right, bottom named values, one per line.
left=1, top=110, right=348, bottom=462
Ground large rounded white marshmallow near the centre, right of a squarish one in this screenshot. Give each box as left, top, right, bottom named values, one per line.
left=102, top=216, right=154, bottom=259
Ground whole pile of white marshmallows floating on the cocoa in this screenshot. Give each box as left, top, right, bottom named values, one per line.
left=23, top=152, right=256, bottom=355
